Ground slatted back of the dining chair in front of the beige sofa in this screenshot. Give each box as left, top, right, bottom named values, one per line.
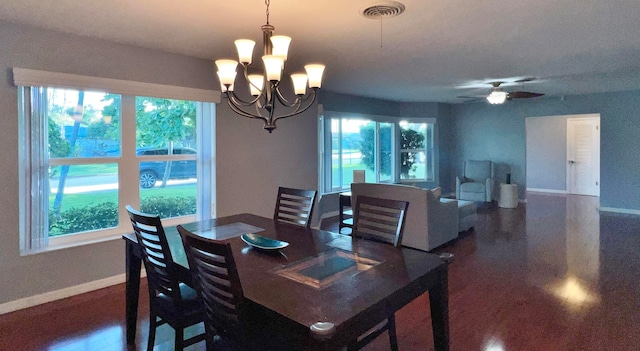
left=353, top=196, right=409, bottom=247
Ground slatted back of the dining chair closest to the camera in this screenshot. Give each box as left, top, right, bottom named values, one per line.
left=177, top=226, right=244, bottom=343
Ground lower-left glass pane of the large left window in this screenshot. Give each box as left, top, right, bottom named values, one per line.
left=49, top=163, right=118, bottom=237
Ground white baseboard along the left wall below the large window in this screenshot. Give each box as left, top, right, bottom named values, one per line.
left=0, top=267, right=147, bottom=314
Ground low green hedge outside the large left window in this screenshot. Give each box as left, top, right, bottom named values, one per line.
left=49, top=196, right=196, bottom=236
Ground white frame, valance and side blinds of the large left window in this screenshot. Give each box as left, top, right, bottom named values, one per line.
left=13, top=68, right=220, bottom=255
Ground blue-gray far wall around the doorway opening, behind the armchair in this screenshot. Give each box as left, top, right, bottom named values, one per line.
left=453, top=91, right=640, bottom=210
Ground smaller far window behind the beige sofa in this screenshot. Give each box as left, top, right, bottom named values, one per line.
left=320, top=112, right=434, bottom=192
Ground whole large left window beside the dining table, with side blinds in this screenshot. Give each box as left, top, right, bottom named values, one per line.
left=19, top=69, right=220, bottom=253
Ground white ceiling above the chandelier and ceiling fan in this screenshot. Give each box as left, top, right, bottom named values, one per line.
left=0, top=0, right=640, bottom=102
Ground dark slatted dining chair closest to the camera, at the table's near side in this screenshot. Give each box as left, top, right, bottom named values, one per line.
left=177, top=225, right=279, bottom=351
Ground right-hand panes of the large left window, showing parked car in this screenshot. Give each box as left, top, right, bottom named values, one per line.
left=136, top=97, right=198, bottom=218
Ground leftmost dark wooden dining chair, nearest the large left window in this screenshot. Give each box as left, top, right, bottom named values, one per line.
left=126, top=206, right=205, bottom=351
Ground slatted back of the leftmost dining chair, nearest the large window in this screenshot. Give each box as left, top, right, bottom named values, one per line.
left=127, top=206, right=181, bottom=303
